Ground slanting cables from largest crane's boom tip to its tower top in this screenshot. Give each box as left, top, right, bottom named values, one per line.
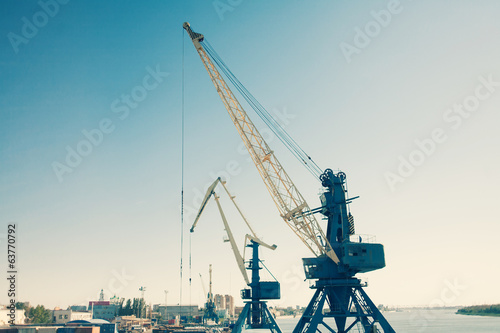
left=201, top=40, right=322, bottom=179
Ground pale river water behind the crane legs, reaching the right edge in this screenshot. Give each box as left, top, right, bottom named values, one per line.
left=270, top=309, right=500, bottom=333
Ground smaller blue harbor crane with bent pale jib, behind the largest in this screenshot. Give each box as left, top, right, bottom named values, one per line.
left=190, top=177, right=281, bottom=333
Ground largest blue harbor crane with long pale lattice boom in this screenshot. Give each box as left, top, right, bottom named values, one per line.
left=183, top=22, right=395, bottom=333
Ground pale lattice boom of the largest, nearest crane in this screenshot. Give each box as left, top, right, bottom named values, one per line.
left=183, top=22, right=339, bottom=263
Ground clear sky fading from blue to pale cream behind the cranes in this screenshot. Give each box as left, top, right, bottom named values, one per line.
left=0, top=0, right=500, bottom=308
